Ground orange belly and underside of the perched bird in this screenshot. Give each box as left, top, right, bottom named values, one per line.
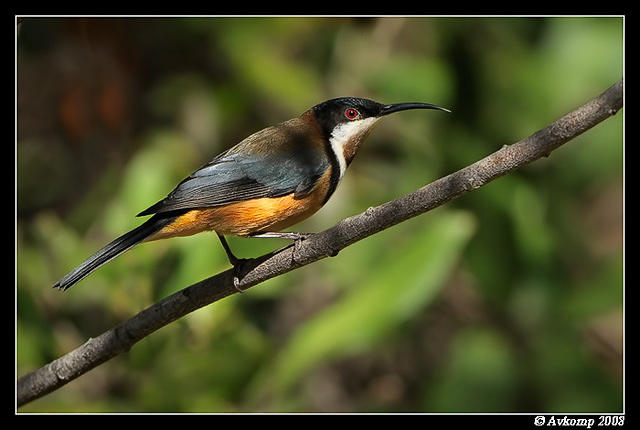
left=147, top=168, right=331, bottom=241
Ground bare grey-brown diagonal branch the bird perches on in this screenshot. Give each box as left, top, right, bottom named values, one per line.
left=17, top=80, right=624, bottom=406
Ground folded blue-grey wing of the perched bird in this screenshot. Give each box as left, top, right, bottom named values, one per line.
left=138, top=142, right=329, bottom=216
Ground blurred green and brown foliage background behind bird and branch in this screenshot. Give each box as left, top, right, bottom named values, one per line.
left=16, top=17, right=624, bottom=412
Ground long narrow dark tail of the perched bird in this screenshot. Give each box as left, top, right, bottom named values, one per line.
left=53, top=215, right=175, bottom=291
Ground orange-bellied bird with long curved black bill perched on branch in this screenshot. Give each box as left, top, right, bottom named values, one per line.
left=53, top=97, right=451, bottom=291
